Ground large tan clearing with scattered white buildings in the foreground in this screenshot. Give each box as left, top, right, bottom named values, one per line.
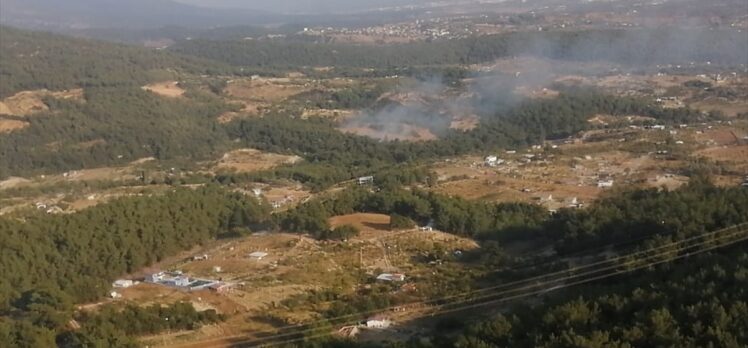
left=136, top=224, right=477, bottom=347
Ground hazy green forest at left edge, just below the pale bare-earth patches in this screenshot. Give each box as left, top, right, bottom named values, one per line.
left=0, top=87, right=234, bottom=177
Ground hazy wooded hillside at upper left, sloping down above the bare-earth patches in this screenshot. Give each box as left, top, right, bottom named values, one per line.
left=0, top=26, right=234, bottom=97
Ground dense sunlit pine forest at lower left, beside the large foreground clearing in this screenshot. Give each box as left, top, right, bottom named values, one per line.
left=0, top=187, right=269, bottom=308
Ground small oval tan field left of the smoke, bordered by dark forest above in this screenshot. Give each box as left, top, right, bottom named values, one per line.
left=214, top=149, right=301, bottom=173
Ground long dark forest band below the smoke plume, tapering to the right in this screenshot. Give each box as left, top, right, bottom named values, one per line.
left=218, top=90, right=710, bottom=190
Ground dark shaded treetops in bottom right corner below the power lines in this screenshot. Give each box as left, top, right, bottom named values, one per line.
left=391, top=244, right=748, bottom=348
